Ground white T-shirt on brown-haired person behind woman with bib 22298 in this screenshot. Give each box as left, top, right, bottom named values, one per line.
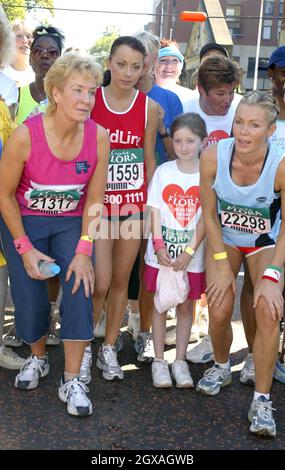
left=182, top=93, right=242, bottom=145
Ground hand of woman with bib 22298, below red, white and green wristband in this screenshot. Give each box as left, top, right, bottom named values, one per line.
left=253, top=279, right=284, bottom=320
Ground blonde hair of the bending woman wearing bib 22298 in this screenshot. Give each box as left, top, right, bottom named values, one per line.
left=239, top=90, right=280, bottom=127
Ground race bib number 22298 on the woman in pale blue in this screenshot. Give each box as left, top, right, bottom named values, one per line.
left=219, top=199, right=271, bottom=235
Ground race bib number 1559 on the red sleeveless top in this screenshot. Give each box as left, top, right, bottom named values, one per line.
left=106, top=149, right=144, bottom=191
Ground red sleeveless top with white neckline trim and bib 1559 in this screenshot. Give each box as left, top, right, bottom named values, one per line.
left=91, top=87, right=148, bottom=217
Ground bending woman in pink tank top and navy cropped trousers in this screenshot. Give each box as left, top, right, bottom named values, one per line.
left=0, top=54, right=109, bottom=416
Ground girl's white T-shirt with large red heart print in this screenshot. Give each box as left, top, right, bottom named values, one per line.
left=145, top=160, right=205, bottom=273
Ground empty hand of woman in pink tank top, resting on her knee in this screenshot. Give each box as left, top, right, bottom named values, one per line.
left=65, top=253, right=95, bottom=297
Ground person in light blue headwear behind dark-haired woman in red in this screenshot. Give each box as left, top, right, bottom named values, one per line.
left=155, top=43, right=194, bottom=112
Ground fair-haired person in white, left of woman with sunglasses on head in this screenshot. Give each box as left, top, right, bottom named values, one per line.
left=3, top=20, right=35, bottom=87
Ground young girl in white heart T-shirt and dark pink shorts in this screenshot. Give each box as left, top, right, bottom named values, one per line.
left=144, top=113, right=207, bottom=388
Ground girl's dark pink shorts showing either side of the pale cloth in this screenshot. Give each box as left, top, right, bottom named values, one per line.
left=144, top=264, right=206, bottom=300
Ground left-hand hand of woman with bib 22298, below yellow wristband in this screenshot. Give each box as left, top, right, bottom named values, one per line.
left=206, top=261, right=236, bottom=307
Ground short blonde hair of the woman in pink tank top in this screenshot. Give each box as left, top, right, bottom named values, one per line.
left=44, top=52, right=103, bottom=114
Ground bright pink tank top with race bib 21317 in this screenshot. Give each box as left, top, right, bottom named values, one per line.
left=16, top=114, right=97, bottom=217
